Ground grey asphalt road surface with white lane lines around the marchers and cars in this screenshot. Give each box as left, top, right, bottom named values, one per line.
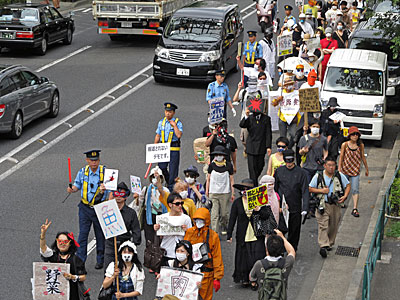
left=0, top=0, right=398, bottom=300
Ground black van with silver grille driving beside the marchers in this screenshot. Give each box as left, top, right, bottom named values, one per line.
left=153, top=1, right=243, bottom=82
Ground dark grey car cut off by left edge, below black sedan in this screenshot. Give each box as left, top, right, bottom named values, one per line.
left=0, top=65, right=60, bottom=139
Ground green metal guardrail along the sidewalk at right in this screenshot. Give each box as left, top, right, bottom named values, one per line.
left=362, top=160, right=400, bottom=300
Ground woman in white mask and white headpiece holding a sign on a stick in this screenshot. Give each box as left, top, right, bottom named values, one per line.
left=103, top=241, right=145, bottom=300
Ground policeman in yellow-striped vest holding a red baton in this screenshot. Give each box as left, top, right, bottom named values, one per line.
left=67, top=150, right=108, bottom=269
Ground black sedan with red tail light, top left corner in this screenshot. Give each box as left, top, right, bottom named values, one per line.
left=0, top=3, right=75, bottom=55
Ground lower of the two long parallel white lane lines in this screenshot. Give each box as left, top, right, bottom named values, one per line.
left=0, top=76, right=153, bottom=182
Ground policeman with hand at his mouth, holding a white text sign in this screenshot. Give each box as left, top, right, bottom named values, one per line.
left=154, top=102, right=183, bottom=191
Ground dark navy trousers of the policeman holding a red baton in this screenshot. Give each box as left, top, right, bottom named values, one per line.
left=76, top=202, right=105, bottom=263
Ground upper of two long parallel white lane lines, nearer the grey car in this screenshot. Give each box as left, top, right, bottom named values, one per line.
left=0, top=63, right=153, bottom=166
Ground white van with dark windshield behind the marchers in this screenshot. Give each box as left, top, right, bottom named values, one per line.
left=321, top=49, right=395, bottom=146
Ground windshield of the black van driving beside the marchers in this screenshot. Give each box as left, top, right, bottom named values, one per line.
left=165, top=17, right=222, bottom=43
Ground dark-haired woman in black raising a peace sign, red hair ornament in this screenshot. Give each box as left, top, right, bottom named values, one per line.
left=40, top=219, right=86, bottom=300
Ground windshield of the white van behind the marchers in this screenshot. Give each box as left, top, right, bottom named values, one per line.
left=324, top=67, right=384, bottom=96
